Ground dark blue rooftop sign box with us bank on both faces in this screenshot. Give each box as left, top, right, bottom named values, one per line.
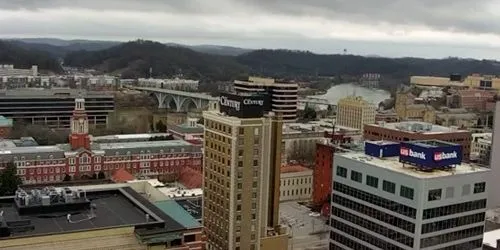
left=399, top=140, right=462, bottom=169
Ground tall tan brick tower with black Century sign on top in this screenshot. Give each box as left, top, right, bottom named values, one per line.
left=203, top=93, right=288, bottom=250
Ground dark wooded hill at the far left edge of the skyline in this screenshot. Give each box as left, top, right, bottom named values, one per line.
left=0, top=41, right=62, bottom=72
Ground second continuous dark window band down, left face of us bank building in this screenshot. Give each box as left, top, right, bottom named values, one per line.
left=331, top=195, right=415, bottom=233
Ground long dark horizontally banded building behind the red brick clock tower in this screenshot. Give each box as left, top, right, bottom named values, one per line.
left=0, top=89, right=115, bottom=128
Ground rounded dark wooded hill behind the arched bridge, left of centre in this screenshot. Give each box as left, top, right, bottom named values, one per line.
left=64, top=40, right=248, bottom=80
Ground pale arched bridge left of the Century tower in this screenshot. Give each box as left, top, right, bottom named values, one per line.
left=126, top=86, right=219, bottom=112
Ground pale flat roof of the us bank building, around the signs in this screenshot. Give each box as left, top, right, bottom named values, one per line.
left=336, top=152, right=489, bottom=179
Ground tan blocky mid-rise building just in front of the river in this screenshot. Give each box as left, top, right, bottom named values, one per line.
left=336, top=96, right=376, bottom=130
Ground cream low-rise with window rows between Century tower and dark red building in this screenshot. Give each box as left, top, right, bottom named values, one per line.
left=280, top=166, right=313, bottom=202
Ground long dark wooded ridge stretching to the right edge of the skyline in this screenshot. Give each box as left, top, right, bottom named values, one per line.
left=236, top=50, right=500, bottom=79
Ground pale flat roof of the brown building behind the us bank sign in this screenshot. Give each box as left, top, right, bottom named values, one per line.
left=369, top=121, right=468, bottom=134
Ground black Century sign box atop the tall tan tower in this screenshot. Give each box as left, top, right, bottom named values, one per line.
left=219, top=93, right=271, bottom=118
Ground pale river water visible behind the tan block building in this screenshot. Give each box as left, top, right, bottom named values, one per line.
left=314, top=83, right=390, bottom=106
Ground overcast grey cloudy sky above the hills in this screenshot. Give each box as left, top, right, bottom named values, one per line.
left=0, top=0, right=500, bottom=59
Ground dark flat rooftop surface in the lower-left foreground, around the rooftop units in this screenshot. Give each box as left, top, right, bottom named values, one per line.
left=0, top=187, right=188, bottom=238
